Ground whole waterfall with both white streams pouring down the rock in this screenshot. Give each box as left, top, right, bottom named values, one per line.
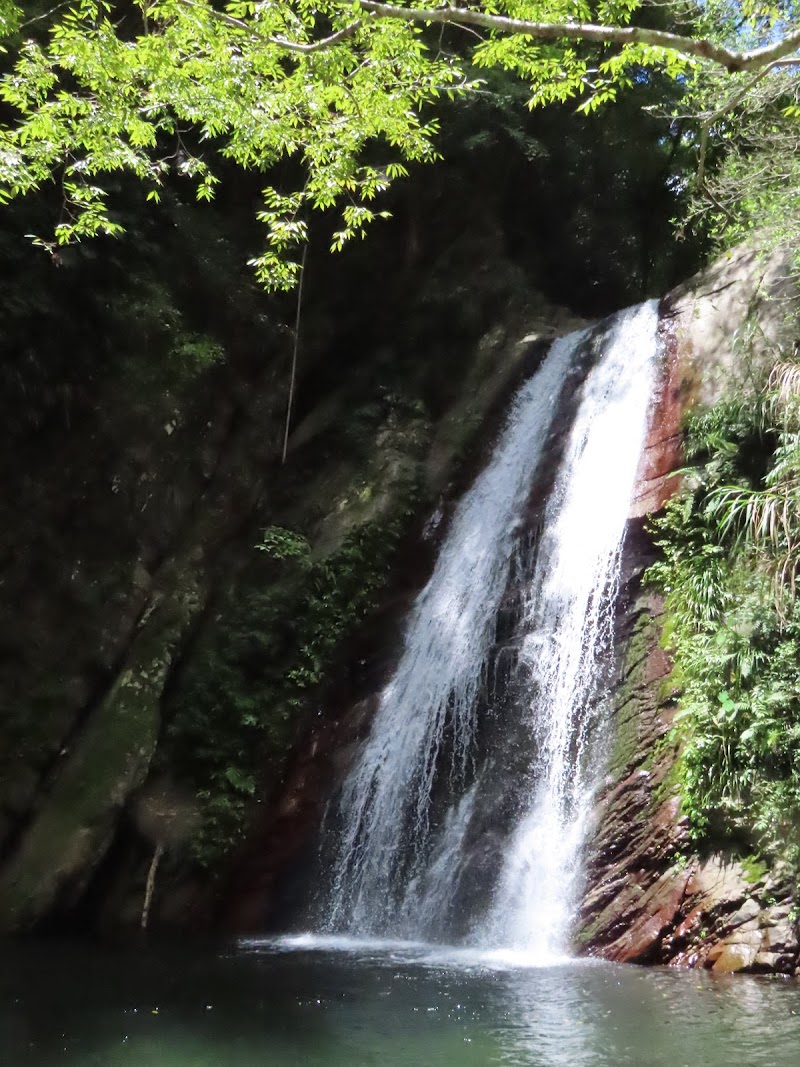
left=315, top=302, right=657, bottom=957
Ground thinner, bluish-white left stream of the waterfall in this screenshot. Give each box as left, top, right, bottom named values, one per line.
left=324, top=334, right=582, bottom=934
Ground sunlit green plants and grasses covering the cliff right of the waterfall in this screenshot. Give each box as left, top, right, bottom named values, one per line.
left=650, top=388, right=800, bottom=870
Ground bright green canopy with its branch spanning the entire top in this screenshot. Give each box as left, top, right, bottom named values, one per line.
left=0, top=0, right=800, bottom=287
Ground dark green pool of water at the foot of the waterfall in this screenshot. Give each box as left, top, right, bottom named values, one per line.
left=0, top=943, right=800, bottom=1067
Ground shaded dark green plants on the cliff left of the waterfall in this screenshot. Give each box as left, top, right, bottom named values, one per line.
left=166, top=514, right=422, bottom=865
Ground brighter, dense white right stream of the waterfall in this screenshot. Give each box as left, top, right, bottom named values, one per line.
left=479, top=301, right=658, bottom=960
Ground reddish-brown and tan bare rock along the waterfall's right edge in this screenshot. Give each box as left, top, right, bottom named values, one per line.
left=576, top=250, right=800, bottom=974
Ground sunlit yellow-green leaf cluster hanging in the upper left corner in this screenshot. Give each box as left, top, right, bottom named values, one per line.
left=0, top=0, right=466, bottom=287
